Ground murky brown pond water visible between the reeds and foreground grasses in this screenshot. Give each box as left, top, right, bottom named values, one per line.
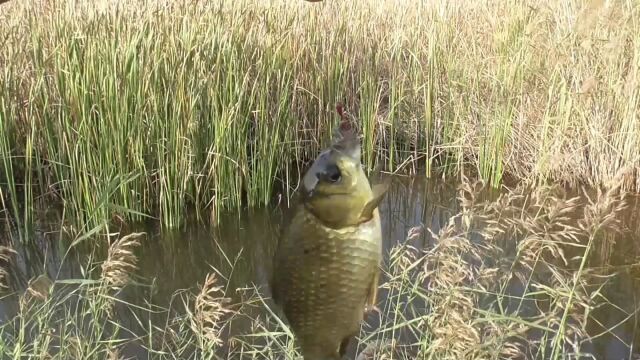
left=0, top=177, right=640, bottom=359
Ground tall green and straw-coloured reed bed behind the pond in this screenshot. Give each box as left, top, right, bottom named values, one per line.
left=0, top=0, right=640, bottom=232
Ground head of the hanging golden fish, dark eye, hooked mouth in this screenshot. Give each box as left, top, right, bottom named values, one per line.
left=302, top=105, right=381, bottom=228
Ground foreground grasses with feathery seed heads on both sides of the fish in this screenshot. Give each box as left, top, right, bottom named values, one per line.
left=0, top=174, right=637, bottom=360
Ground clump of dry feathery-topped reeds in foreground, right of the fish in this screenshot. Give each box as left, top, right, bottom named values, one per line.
left=369, top=174, right=626, bottom=359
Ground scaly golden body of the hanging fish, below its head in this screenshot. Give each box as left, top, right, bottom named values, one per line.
left=274, top=209, right=381, bottom=359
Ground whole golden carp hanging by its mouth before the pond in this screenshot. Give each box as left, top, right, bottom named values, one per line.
left=272, top=105, right=387, bottom=360
